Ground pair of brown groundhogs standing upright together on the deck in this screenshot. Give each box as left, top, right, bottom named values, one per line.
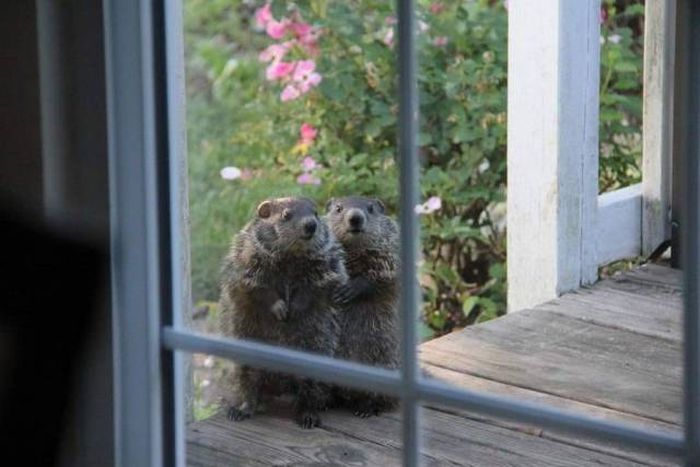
left=220, top=197, right=399, bottom=428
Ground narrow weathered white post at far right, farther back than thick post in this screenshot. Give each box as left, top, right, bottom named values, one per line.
left=642, top=0, right=676, bottom=255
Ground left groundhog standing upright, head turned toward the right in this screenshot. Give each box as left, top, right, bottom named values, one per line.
left=220, top=198, right=347, bottom=428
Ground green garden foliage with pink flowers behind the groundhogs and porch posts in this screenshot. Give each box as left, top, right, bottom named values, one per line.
left=185, top=0, right=641, bottom=337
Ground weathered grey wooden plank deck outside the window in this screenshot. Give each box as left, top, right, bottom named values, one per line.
left=187, top=265, right=682, bottom=466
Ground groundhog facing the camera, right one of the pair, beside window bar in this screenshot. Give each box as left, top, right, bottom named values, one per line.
left=326, top=197, right=400, bottom=417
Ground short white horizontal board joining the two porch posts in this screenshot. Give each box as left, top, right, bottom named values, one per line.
left=596, top=184, right=642, bottom=266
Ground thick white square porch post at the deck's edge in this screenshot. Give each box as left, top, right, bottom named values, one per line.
left=508, top=0, right=600, bottom=311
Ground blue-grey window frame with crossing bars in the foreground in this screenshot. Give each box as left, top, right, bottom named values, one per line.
left=105, top=0, right=700, bottom=466
